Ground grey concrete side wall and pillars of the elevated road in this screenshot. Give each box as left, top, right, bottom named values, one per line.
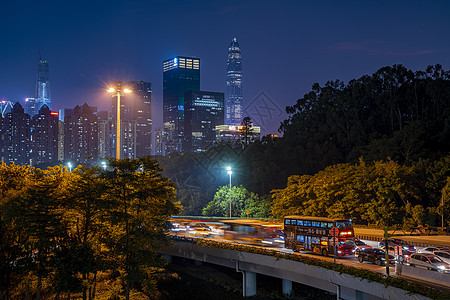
left=160, top=241, right=429, bottom=300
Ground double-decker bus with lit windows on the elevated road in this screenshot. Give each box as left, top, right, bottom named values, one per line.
left=283, top=216, right=355, bottom=256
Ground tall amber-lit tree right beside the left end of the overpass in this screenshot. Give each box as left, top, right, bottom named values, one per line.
left=106, top=157, right=181, bottom=299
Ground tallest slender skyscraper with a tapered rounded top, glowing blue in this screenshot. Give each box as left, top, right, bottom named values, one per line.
left=225, top=38, right=242, bottom=125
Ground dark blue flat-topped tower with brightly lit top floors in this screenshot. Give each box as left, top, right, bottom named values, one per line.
left=163, top=56, right=200, bottom=153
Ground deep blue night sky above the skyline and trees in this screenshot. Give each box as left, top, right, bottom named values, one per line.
left=0, top=0, right=450, bottom=133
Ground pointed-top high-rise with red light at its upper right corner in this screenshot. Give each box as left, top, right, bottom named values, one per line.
left=31, top=104, right=59, bottom=166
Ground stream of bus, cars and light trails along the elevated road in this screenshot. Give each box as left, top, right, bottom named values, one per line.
left=171, top=216, right=450, bottom=287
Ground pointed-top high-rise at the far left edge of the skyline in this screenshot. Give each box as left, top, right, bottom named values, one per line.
left=0, top=102, right=31, bottom=165
